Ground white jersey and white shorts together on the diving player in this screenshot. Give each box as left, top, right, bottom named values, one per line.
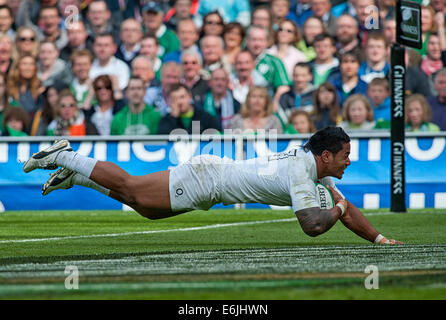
left=169, top=149, right=340, bottom=212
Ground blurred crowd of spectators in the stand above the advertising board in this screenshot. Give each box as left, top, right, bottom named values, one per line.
left=0, top=0, right=446, bottom=136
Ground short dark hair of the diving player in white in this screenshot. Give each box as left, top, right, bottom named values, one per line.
left=303, top=126, right=350, bottom=156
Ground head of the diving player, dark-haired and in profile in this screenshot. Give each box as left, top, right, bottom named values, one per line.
left=303, top=126, right=350, bottom=179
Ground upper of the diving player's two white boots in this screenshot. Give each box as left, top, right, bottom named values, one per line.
left=23, top=140, right=73, bottom=173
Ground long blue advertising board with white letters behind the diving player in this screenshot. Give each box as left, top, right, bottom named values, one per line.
left=0, top=136, right=446, bottom=210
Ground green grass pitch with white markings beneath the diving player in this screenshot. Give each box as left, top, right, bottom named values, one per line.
left=0, top=209, right=446, bottom=300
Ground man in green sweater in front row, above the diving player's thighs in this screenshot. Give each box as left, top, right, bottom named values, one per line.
left=111, top=76, right=161, bottom=135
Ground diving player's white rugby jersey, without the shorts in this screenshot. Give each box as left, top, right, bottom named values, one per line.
left=220, top=149, right=337, bottom=212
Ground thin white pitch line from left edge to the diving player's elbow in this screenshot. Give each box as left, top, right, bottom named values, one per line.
left=0, top=218, right=296, bottom=244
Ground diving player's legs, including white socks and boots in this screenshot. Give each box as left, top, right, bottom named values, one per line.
left=23, top=140, right=185, bottom=219
